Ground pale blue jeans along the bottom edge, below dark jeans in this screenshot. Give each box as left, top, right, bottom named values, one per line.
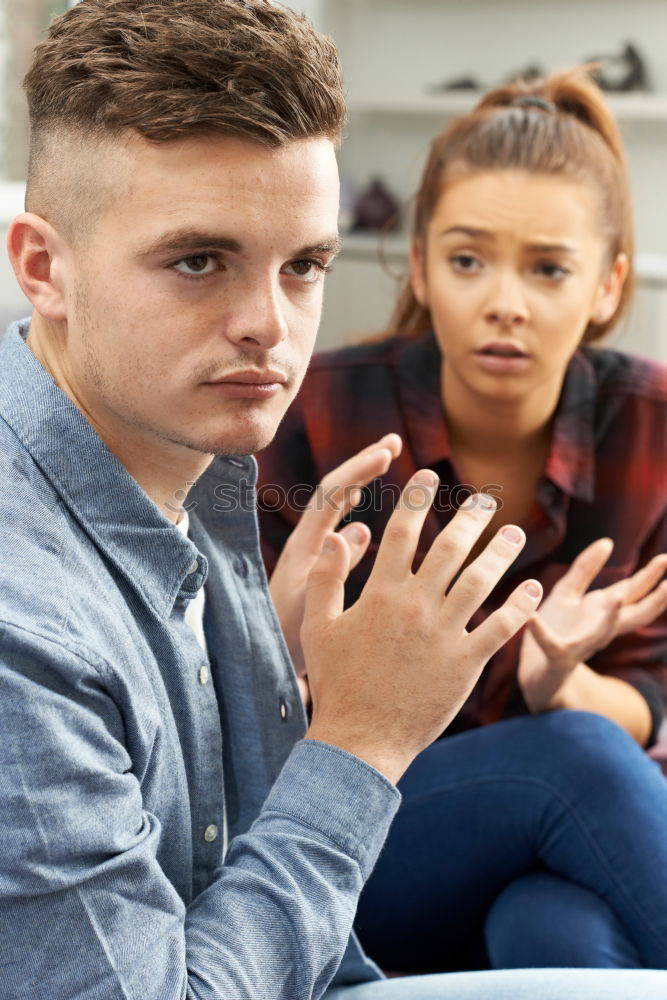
left=324, top=969, right=667, bottom=1000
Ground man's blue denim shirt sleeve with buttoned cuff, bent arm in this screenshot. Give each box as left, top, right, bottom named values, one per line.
left=0, top=626, right=399, bottom=1000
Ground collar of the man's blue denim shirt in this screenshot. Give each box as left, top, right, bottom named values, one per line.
left=0, top=320, right=254, bottom=617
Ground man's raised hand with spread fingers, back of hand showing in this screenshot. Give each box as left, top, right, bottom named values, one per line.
left=301, top=470, right=542, bottom=781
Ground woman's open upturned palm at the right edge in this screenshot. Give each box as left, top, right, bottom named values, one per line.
left=518, top=538, right=667, bottom=712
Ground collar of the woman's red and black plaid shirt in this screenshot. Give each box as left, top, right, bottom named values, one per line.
left=398, top=331, right=596, bottom=501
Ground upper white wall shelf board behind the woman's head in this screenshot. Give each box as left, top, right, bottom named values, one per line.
left=349, top=90, right=667, bottom=122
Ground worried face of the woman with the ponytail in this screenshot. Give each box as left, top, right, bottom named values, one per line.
left=412, top=170, right=627, bottom=401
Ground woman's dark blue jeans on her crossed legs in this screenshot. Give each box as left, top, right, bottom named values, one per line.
left=350, top=711, right=667, bottom=968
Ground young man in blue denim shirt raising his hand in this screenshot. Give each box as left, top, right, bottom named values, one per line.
left=0, top=0, right=664, bottom=1000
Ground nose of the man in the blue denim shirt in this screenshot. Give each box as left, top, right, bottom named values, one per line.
left=225, top=279, right=289, bottom=350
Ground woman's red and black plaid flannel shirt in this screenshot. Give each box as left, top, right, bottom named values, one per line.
left=259, top=334, right=667, bottom=735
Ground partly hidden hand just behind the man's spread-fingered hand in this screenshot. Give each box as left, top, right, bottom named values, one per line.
left=269, top=434, right=402, bottom=674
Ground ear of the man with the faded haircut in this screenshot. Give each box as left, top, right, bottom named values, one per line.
left=7, top=212, right=66, bottom=321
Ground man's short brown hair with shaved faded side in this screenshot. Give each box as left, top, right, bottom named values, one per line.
left=24, top=0, right=346, bottom=236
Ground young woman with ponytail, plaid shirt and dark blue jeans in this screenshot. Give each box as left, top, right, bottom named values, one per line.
left=260, top=71, right=667, bottom=971
